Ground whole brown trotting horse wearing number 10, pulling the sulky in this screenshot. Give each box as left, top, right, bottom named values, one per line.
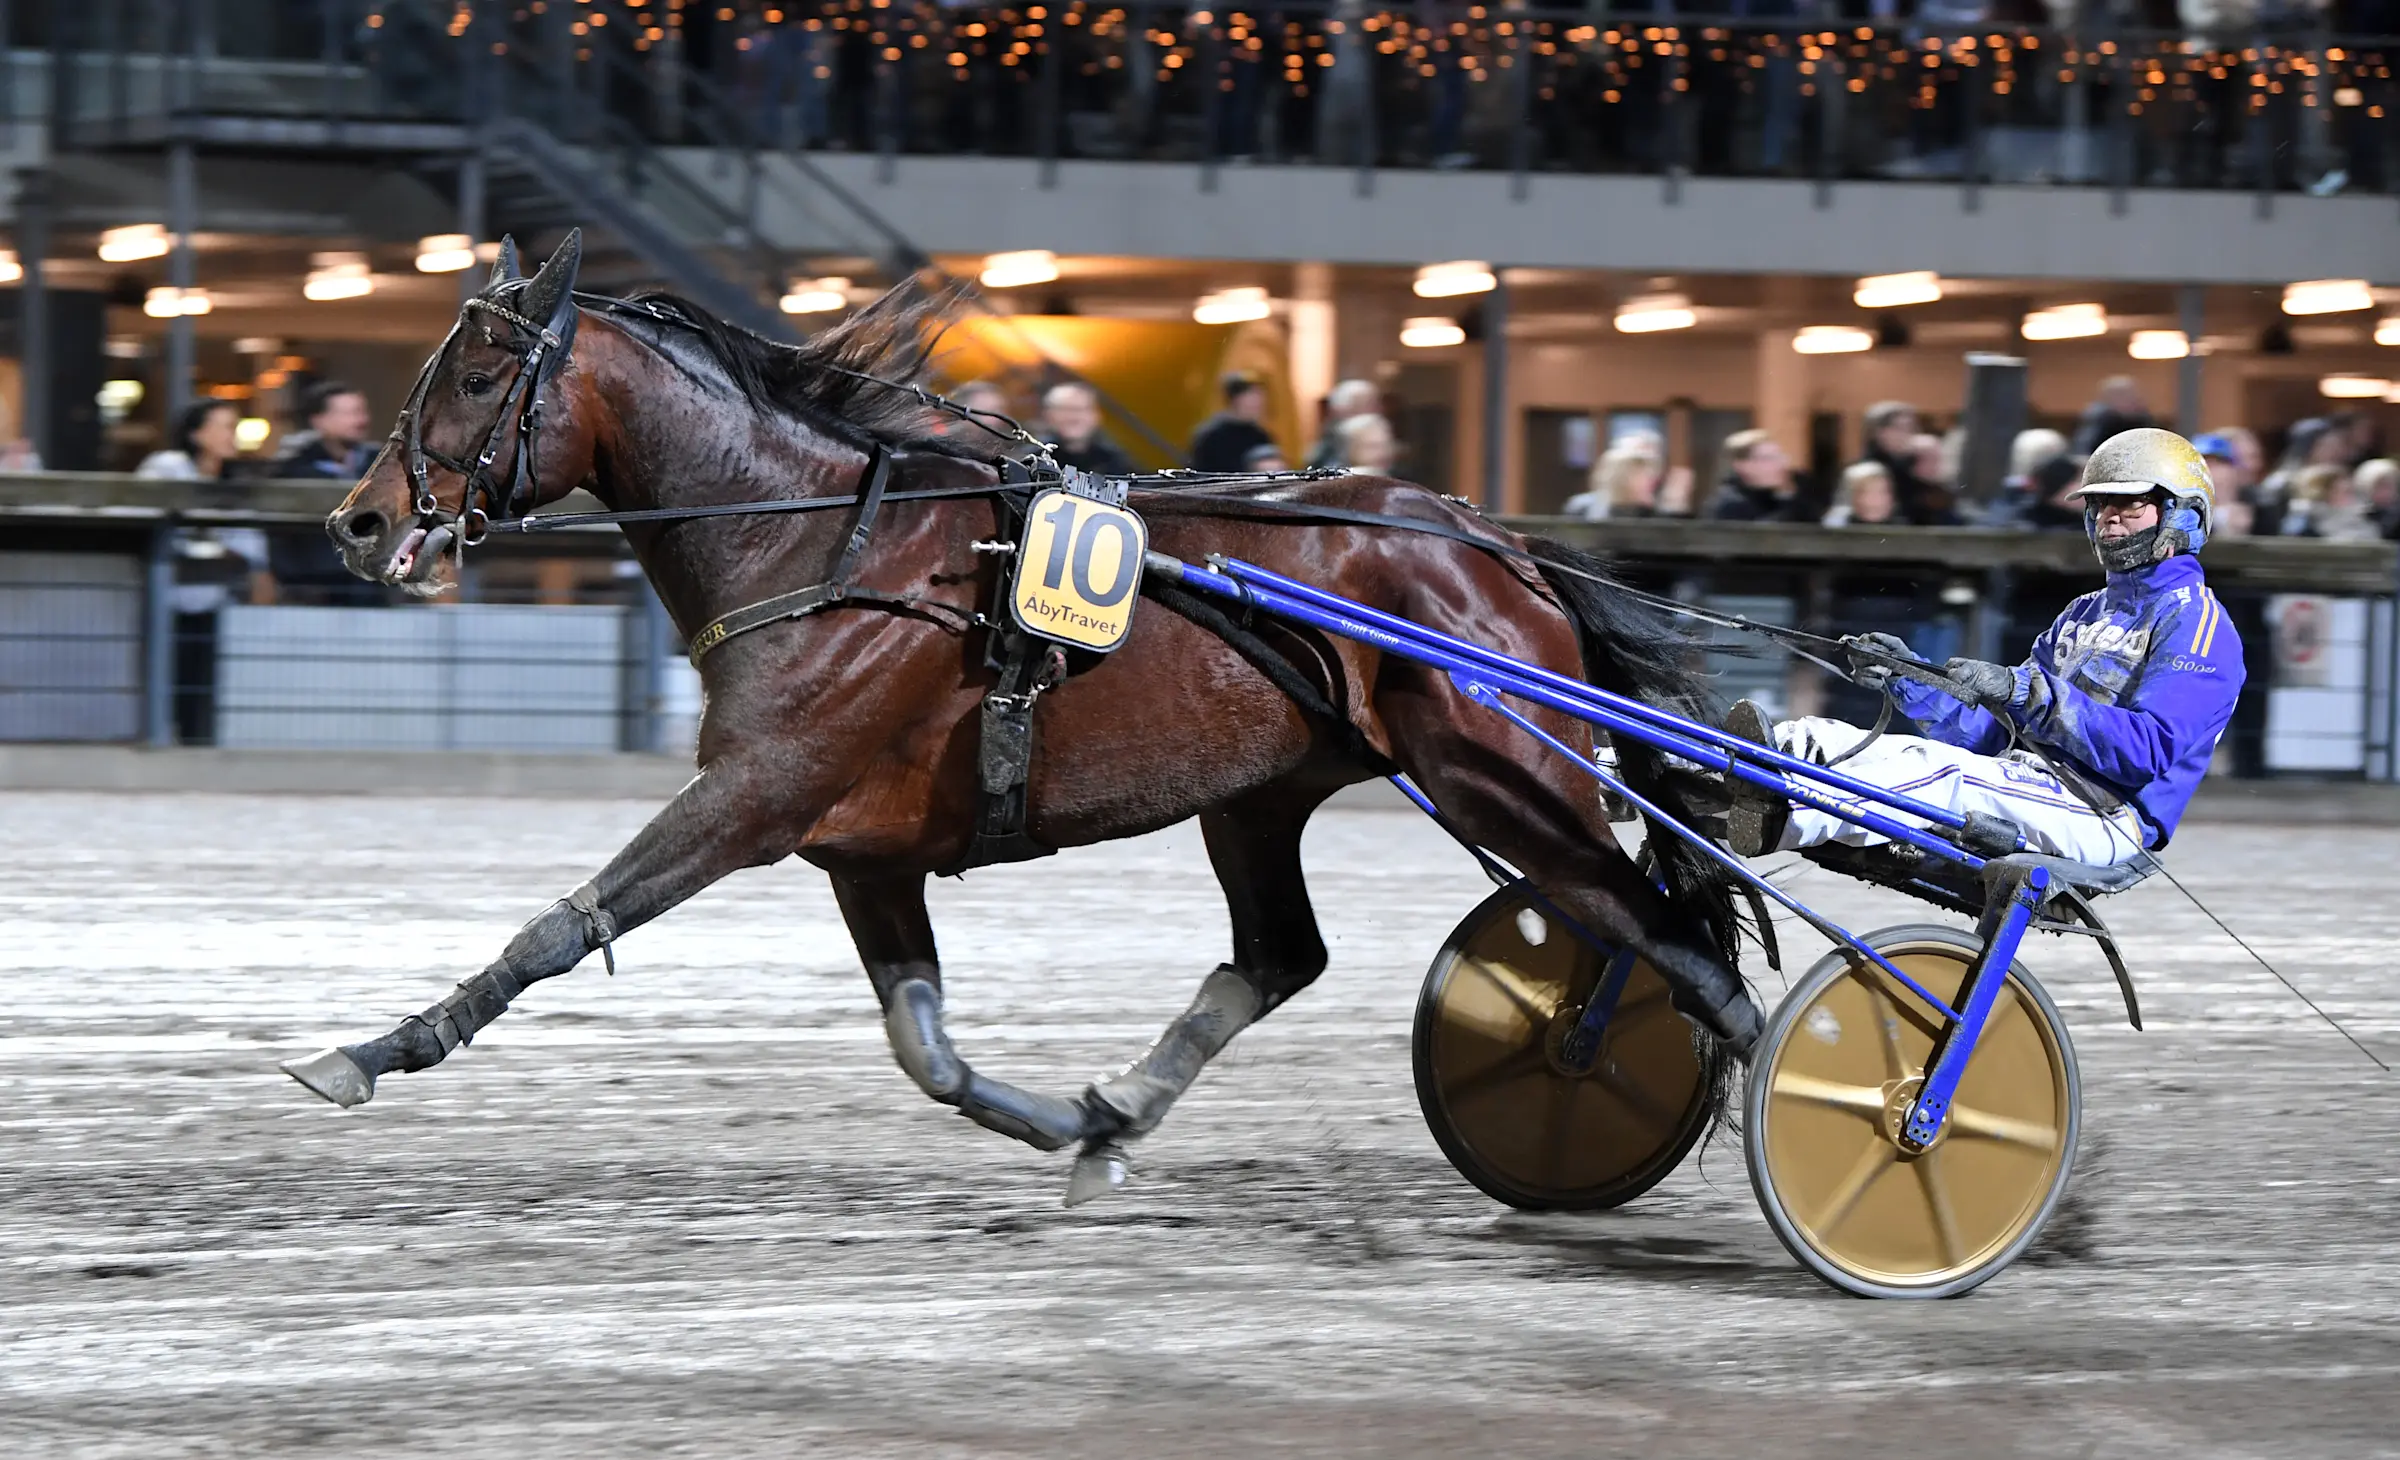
left=286, top=235, right=1759, bottom=1201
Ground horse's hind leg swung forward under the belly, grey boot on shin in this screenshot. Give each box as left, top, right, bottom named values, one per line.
left=1066, top=785, right=1327, bottom=1205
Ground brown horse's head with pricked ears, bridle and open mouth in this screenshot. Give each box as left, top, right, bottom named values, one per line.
left=324, top=231, right=593, bottom=598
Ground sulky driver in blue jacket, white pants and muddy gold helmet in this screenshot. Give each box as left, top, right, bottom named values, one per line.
left=1726, top=427, right=2242, bottom=864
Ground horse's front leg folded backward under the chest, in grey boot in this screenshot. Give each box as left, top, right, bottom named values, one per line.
left=833, top=872, right=1111, bottom=1150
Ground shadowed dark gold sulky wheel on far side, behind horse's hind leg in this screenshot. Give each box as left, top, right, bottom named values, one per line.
left=1414, top=886, right=1726, bottom=1210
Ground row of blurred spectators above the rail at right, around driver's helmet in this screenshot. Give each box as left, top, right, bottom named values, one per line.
left=1567, top=377, right=2400, bottom=540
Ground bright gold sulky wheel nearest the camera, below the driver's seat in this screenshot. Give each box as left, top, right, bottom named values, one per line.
left=1742, top=925, right=2083, bottom=1297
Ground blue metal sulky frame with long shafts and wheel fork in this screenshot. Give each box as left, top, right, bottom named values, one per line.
left=1147, top=552, right=2052, bottom=1148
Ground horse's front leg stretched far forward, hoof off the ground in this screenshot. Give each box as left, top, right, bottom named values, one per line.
left=283, top=759, right=806, bottom=1105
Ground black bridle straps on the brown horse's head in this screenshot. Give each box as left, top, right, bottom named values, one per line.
left=386, top=288, right=578, bottom=557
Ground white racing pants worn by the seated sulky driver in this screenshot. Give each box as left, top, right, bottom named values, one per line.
left=1776, top=718, right=2146, bottom=867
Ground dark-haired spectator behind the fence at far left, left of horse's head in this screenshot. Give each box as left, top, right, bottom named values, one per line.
left=134, top=401, right=270, bottom=744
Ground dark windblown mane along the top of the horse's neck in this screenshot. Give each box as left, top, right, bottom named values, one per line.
left=612, top=283, right=982, bottom=454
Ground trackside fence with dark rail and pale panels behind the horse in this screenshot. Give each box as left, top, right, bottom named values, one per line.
left=0, top=473, right=2400, bottom=780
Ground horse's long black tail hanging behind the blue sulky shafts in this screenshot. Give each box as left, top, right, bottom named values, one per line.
left=1524, top=535, right=1742, bottom=968
